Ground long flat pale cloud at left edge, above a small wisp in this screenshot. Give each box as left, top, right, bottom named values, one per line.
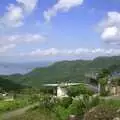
left=0, top=33, right=46, bottom=45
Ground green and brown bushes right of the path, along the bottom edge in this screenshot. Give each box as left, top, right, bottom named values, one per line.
left=8, top=96, right=120, bottom=120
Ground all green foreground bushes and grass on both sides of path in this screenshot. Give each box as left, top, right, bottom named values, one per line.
left=0, top=76, right=120, bottom=120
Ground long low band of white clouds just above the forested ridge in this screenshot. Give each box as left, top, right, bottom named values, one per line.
left=20, top=48, right=120, bottom=58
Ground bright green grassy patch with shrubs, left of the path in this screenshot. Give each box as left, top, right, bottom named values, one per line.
left=0, top=88, right=41, bottom=114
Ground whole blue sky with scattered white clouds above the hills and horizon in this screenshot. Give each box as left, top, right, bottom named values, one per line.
left=0, top=0, right=120, bottom=62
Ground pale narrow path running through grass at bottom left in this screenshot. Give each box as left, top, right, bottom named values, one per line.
left=0, top=103, right=39, bottom=120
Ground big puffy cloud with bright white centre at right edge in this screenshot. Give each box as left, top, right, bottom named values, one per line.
left=99, top=11, right=120, bottom=44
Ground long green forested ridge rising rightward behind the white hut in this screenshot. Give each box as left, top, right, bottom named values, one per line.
left=3, top=56, right=120, bottom=86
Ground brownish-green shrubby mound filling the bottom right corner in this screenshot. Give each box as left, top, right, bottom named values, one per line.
left=84, top=100, right=120, bottom=120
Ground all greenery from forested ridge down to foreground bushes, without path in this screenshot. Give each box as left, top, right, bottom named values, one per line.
left=0, top=56, right=120, bottom=120
